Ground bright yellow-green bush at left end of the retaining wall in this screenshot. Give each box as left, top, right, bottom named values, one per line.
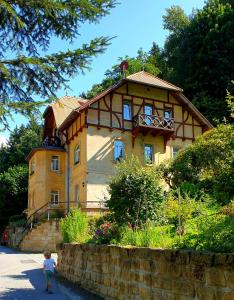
left=60, top=209, right=90, bottom=243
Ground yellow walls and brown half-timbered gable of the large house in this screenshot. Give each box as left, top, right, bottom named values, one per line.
left=28, top=72, right=212, bottom=217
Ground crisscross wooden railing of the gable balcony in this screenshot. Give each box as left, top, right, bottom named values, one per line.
left=133, top=114, right=174, bottom=130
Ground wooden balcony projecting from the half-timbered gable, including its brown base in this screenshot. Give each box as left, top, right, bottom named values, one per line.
left=133, top=114, right=175, bottom=136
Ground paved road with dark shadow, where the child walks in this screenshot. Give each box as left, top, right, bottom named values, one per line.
left=0, top=246, right=100, bottom=300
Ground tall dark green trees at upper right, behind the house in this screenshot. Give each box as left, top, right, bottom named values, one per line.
left=164, top=0, right=234, bottom=121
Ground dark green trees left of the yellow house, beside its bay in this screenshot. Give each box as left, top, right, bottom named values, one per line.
left=0, top=119, right=42, bottom=229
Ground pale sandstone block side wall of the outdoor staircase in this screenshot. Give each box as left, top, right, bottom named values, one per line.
left=19, top=219, right=62, bottom=252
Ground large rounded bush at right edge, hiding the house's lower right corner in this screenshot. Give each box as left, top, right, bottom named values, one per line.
left=165, top=125, right=234, bottom=204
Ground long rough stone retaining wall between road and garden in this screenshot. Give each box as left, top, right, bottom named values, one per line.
left=58, top=244, right=234, bottom=300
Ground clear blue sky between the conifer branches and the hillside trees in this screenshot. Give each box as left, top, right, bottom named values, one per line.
left=0, top=0, right=204, bottom=137
